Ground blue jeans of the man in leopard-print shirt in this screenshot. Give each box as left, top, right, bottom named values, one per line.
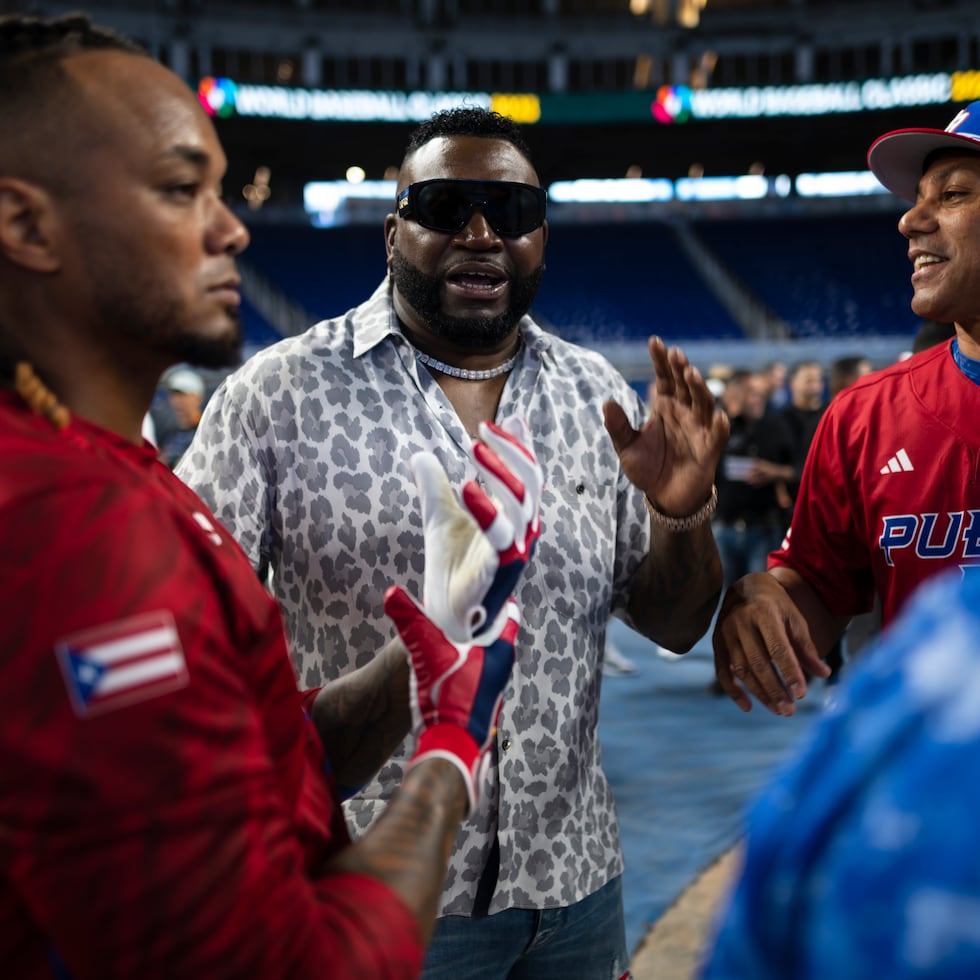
left=422, top=878, right=630, bottom=980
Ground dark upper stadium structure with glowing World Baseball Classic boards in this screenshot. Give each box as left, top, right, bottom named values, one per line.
left=24, top=0, right=980, bottom=213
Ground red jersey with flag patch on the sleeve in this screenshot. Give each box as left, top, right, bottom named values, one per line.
left=0, top=394, right=422, bottom=980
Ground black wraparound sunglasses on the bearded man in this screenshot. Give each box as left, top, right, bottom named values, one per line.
left=395, top=180, right=547, bottom=238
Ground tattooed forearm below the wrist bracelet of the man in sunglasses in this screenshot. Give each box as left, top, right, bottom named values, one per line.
left=629, top=524, right=722, bottom=653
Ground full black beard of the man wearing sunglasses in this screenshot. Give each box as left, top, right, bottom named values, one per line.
left=391, top=249, right=544, bottom=350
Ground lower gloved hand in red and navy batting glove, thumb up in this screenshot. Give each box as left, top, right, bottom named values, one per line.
left=384, top=586, right=520, bottom=812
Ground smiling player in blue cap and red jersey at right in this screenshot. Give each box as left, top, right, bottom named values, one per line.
left=712, top=102, right=980, bottom=715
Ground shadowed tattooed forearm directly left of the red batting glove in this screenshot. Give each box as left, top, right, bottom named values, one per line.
left=312, top=641, right=411, bottom=786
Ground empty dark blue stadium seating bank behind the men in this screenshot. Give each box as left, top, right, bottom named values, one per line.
left=237, top=213, right=918, bottom=356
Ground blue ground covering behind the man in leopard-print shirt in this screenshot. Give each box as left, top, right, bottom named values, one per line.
left=600, top=622, right=825, bottom=952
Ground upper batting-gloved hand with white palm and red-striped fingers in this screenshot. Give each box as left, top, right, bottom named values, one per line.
left=412, top=417, right=544, bottom=643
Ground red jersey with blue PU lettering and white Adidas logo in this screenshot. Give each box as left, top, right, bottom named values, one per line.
left=769, top=344, right=980, bottom=623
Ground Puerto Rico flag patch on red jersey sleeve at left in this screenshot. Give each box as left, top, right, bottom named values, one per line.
left=55, top=610, right=188, bottom=717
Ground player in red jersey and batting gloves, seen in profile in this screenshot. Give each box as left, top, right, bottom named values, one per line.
left=0, top=14, right=540, bottom=980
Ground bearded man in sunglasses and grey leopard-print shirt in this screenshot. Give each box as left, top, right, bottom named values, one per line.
left=179, top=108, right=728, bottom=980
